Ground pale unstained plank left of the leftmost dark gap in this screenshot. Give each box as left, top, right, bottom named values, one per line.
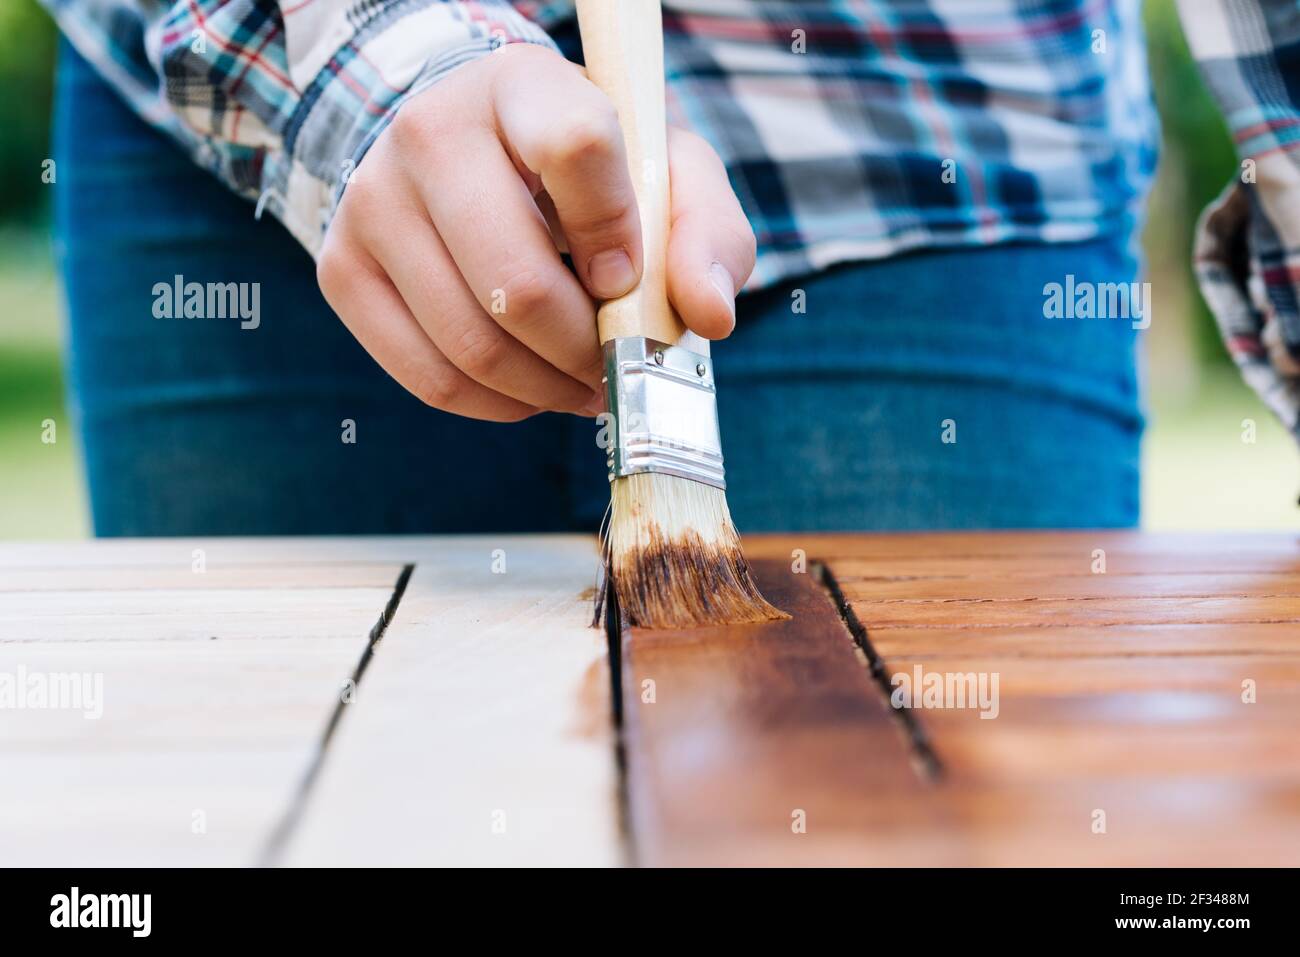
left=0, top=544, right=395, bottom=866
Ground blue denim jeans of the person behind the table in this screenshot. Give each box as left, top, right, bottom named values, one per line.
left=56, top=44, right=1143, bottom=536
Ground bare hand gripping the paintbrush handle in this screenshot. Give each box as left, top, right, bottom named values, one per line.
left=316, top=44, right=754, bottom=421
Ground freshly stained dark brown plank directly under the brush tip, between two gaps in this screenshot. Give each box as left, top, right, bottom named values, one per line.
left=623, top=562, right=954, bottom=866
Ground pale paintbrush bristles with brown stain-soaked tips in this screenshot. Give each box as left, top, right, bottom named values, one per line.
left=605, top=472, right=789, bottom=628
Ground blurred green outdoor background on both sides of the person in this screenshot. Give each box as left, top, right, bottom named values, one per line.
left=0, top=0, right=1300, bottom=540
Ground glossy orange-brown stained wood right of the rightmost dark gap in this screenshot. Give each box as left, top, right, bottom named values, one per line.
left=806, top=532, right=1300, bottom=866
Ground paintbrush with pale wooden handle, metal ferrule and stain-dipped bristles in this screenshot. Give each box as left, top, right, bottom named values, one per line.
left=577, top=0, right=788, bottom=628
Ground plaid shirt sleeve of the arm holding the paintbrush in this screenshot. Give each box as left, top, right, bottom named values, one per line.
left=42, top=0, right=554, bottom=256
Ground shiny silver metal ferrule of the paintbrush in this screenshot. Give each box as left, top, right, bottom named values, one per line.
left=602, top=335, right=727, bottom=489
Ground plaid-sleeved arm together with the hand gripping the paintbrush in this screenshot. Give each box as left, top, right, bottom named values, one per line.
left=43, top=0, right=754, bottom=420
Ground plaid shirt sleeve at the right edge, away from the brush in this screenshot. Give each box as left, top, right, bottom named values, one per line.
left=1178, top=0, right=1300, bottom=441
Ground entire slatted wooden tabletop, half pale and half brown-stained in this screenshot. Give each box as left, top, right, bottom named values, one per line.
left=0, top=532, right=1300, bottom=865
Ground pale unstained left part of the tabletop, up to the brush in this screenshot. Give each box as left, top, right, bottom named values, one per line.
left=0, top=537, right=624, bottom=866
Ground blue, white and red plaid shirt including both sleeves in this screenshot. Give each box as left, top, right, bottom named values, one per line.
left=35, top=0, right=1300, bottom=434
